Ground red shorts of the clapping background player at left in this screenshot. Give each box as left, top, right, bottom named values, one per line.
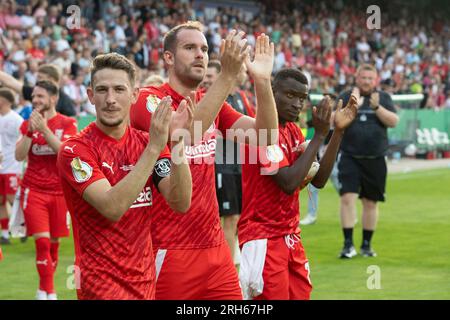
left=20, top=188, right=69, bottom=238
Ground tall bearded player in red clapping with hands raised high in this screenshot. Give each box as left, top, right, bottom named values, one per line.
left=130, top=22, right=278, bottom=299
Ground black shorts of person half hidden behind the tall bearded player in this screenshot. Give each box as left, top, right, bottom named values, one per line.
left=216, top=173, right=242, bottom=217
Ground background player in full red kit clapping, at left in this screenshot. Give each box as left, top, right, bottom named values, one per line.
left=15, top=80, right=77, bottom=300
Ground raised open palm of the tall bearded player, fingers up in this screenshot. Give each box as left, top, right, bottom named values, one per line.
left=245, top=33, right=274, bottom=80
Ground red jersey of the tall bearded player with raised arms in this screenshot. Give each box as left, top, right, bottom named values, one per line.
left=130, top=84, right=242, bottom=249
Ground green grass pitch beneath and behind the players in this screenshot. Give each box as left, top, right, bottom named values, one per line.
left=0, top=169, right=450, bottom=300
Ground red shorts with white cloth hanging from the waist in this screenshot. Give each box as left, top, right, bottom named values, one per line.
left=239, top=235, right=312, bottom=300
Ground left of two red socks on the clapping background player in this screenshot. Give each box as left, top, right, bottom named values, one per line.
left=36, top=238, right=55, bottom=293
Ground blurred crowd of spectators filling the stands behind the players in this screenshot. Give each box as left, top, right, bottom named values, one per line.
left=0, top=0, right=450, bottom=115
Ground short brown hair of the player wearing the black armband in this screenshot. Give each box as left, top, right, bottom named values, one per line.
left=91, top=52, right=136, bottom=86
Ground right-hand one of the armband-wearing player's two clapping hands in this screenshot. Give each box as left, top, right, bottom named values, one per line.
left=170, top=91, right=195, bottom=142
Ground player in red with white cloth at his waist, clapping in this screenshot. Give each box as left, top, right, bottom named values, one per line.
left=238, top=69, right=357, bottom=299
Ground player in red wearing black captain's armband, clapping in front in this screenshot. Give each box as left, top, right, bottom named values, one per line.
left=58, top=53, right=193, bottom=299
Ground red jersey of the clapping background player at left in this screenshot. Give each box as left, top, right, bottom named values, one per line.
left=20, top=113, right=77, bottom=195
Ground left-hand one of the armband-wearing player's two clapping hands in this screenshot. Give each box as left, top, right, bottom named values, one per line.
left=148, top=97, right=172, bottom=153
